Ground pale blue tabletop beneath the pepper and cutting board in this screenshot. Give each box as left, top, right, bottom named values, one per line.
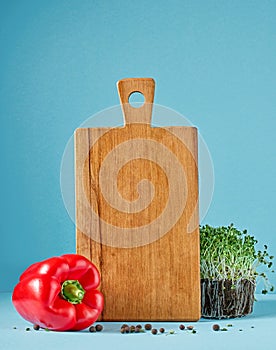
left=0, top=293, right=276, bottom=350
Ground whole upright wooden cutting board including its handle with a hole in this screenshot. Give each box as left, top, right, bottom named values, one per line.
left=75, top=78, right=201, bottom=321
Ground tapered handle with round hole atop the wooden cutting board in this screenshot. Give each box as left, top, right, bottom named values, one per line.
left=117, top=78, right=155, bottom=125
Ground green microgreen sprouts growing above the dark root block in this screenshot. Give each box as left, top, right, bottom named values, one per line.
left=200, top=224, right=274, bottom=294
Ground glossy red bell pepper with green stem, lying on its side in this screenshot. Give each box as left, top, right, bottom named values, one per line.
left=12, top=254, right=104, bottom=331
